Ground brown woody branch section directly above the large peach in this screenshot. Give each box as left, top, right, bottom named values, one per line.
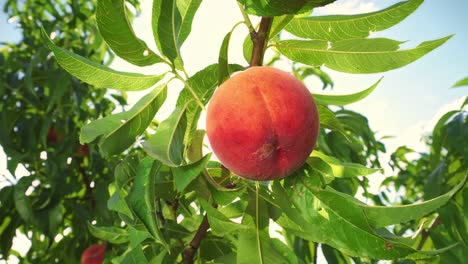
left=250, top=17, right=273, bottom=66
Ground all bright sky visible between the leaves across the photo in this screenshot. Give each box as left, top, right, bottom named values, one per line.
left=0, top=0, right=468, bottom=263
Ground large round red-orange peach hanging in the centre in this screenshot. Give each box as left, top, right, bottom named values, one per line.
left=206, top=66, right=319, bottom=180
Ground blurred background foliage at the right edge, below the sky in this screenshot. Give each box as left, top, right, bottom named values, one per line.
left=374, top=100, right=468, bottom=263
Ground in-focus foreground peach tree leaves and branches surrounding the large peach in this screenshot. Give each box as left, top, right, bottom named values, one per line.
left=38, top=0, right=466, bottom=263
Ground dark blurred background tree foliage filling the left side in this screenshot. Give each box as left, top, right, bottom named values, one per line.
left=0, top=1, right=139, bottom=263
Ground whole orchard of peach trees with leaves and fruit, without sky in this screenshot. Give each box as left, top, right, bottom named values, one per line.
left=0, top=0, right=468, bottom=264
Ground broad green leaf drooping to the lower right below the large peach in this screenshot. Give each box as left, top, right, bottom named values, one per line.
left=273, top=175, right=416, bottom=259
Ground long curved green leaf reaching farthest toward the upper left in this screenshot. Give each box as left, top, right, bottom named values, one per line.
left=42, top=29, right=164, bottom=91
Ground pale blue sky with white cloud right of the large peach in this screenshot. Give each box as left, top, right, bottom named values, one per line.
left=310, top=0, right=468, bottom=153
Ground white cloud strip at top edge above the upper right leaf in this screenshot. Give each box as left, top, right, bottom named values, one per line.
left=314, top=0, right=379, bottom=15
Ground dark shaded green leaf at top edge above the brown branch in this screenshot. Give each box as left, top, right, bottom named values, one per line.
left=237, top=0, right=336, bottom=17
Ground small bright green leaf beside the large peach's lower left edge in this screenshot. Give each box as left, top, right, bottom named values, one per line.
left=171, top=154, right=211, bottom=192
